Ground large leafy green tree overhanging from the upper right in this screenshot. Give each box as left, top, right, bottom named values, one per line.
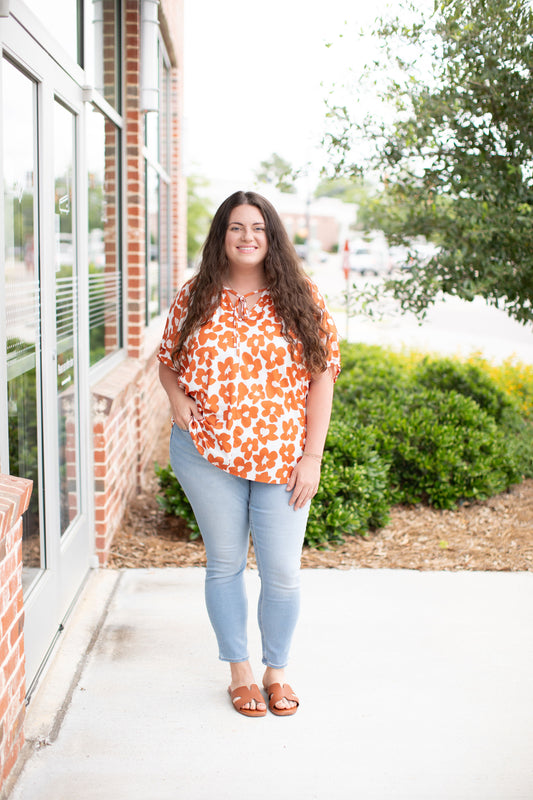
left=327, top=0, right=533, bottom=323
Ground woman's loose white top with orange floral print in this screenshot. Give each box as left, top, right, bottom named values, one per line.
left=158, top=281, right=340, bottom=484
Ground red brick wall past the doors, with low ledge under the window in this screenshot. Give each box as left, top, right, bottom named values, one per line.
left=88, top=0, right=187, bottom=565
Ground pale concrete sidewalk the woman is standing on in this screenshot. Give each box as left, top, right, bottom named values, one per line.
left=6, top=569, right=533, bottom=800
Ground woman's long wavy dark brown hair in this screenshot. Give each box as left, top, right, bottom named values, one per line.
left=172, top=191, right=329, bottom=374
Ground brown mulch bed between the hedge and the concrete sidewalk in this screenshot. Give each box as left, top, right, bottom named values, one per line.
left=108, top=425, right=533, bottom=571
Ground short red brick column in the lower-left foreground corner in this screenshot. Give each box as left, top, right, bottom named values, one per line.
left=0, top=474, right=32, bottom=785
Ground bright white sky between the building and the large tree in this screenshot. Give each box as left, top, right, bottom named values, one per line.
left=184, top=0, right=410, bottom=188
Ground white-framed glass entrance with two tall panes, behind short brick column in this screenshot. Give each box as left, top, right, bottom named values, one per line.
left=0, top=28, right=93, bottom=685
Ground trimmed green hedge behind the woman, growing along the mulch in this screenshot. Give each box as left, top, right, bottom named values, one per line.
left=156, top=343, right=533, bottom=547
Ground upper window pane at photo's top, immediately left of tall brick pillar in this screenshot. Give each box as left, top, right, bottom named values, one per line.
left=84, top=0, right=121, bottom=112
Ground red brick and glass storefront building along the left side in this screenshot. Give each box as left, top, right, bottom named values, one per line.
left=0, top=0, right=186, bottom=778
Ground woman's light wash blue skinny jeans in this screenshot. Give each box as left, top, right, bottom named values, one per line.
left=170, top=425, right=309, bottom=668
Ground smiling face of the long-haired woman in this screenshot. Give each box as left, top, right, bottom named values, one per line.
left=225, top=205, right=268, bottom=271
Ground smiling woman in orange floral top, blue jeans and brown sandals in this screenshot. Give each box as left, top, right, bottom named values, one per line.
left=158, top=192, right=340, bottom=717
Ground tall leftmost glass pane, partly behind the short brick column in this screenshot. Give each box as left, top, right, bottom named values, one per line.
left=2, top=61, right=44, bottom=591
